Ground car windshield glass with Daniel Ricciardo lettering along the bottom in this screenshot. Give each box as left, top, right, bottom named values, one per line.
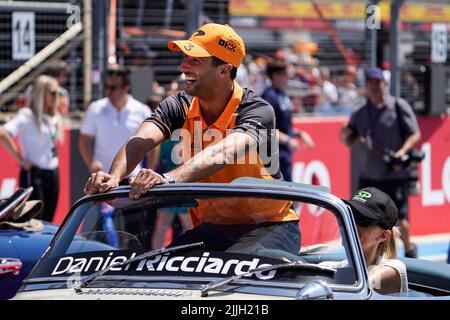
left=27, top=186, right=357, bottom=294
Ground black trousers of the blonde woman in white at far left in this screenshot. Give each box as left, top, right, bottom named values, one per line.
left=19, top=167, right=59, bottom=222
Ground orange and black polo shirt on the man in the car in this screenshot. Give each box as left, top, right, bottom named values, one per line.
left=146, top=82, right=298, bottom=226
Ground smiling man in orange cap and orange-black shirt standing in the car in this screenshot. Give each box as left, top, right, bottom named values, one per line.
left=84, top=23, right=300, bottom=253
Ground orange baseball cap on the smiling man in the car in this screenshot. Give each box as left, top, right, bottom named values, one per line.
left=167, top=23, right=245, bottom=68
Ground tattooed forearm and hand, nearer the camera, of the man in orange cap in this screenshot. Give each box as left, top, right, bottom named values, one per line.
left=130, top=132, right=257, bottom=199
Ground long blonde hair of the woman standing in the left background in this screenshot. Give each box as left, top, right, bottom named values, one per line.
left=28, top=75, right=62, bottom=139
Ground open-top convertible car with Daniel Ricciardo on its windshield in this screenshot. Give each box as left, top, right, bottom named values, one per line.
left=10, top=178, right=450, bottom=301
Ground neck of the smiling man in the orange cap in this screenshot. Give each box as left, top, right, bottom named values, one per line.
left=198, top=81, right=234, bottom=126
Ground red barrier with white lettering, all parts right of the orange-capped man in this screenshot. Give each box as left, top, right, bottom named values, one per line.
left=293, top=117, right=450, bottom=244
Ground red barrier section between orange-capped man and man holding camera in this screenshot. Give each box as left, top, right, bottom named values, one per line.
left=292, top=117, right=351, bottom=245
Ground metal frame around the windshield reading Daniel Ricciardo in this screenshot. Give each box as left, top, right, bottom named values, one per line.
left=24, top=182, right=370, bottom=295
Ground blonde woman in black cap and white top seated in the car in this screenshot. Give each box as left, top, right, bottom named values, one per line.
left=346, top=187, right=408, bottom=295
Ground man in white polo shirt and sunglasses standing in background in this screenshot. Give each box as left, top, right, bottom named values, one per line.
left=79, top=69, right=151, bottom=176
